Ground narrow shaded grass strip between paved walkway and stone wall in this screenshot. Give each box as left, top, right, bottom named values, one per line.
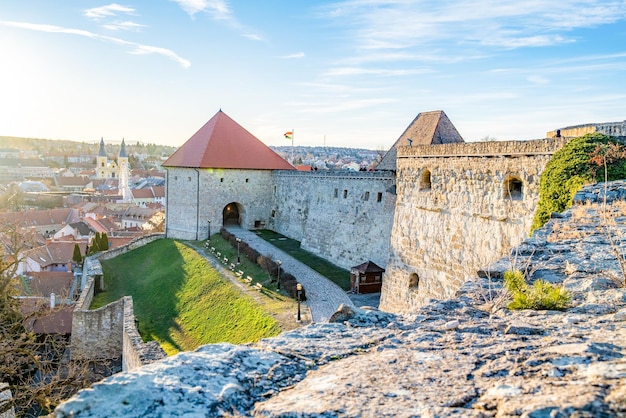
left=249, top=229, right=350, bottom=290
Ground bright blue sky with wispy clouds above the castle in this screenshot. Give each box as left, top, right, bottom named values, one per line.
left=0, top=0, right=626, bottom=149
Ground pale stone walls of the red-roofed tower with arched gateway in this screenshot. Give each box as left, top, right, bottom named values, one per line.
left=166, top=168, right=273, bottom=240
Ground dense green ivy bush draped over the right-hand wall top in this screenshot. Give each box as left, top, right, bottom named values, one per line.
left=531, top=133, right=626, bottom=232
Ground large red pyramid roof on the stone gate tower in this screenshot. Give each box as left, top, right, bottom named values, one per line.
left=163, top=110, right=295, bottom=170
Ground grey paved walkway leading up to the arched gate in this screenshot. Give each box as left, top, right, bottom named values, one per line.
left=226, top=225, right=354, bottom=322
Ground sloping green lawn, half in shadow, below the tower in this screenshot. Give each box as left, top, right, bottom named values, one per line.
left=91, top=239, right=281, bottom=355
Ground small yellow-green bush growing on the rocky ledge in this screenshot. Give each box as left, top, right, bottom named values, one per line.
left=504, top=270, right=571, bottom=311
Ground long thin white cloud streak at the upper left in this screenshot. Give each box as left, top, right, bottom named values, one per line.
left=0, top=21, right=191, bottom=68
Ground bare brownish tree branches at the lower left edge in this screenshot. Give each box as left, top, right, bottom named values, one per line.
left=0, top=220, right=110, bottom=416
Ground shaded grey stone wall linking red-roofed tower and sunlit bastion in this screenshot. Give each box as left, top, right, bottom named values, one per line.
left=269, top=171, right=396, bottom=268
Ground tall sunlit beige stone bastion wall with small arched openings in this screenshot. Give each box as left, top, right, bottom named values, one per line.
left=380, top=140, right=566, bottom=312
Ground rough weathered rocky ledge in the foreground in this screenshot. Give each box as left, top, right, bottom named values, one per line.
left=54, top=183, right=626, bottom=417
